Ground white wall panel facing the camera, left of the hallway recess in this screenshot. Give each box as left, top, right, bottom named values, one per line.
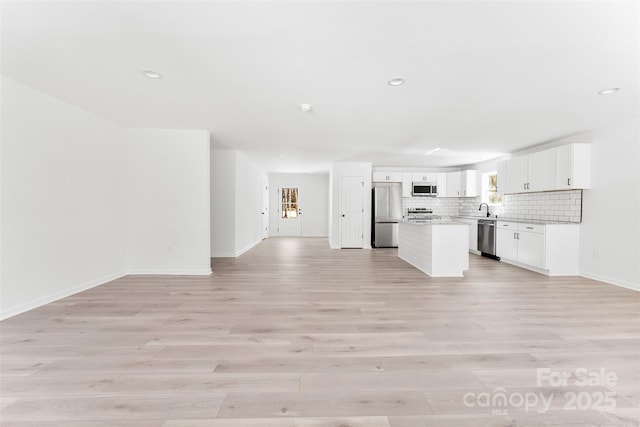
left=127, top=129, right=211, bottom=274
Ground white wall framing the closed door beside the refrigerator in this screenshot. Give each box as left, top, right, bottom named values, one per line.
left=329, top=162, right=372, bottom=249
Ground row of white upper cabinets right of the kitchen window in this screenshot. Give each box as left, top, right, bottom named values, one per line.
left=498, top=144, right=591, bottom=194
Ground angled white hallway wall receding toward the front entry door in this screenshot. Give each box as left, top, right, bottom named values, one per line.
left=210, top=149, right=267, bottom=257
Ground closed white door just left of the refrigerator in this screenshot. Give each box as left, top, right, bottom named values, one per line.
left=340, top=176, right=364, bottom=249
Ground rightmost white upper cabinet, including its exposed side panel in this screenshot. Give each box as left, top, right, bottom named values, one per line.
left=555, top=144, right=591, bottom=190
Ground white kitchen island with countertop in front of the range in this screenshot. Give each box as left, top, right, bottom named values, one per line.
left=398, top=220, right=469, bottom=277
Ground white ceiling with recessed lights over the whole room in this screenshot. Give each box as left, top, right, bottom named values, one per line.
left=1, top=0, right=640, bottom=172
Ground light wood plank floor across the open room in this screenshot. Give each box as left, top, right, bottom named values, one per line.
left=0, top=238, right=640, bottom=427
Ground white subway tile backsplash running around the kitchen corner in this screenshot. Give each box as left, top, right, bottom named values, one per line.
left=402, top=190, right=582, bottom=223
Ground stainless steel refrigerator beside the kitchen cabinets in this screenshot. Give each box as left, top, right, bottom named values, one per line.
left=371, top=183, right=402, bottom=248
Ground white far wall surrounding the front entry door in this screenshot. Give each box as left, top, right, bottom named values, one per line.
left=269, top=173, right=329, bottom=237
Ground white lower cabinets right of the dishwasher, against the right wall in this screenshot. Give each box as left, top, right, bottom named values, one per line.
left=496, top=221, right=579, bottom=276
